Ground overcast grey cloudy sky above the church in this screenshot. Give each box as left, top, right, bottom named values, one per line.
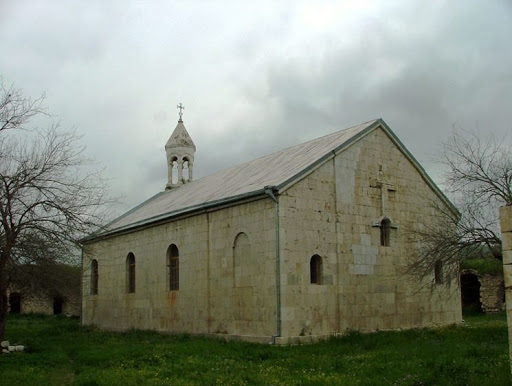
left=0, top=0, right=512, bottom=213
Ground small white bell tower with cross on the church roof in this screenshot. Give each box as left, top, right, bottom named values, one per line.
left=165, top=103, right=196, bottom=190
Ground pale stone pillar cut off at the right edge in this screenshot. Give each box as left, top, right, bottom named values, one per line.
left=500, top=205, right=512, bottom=371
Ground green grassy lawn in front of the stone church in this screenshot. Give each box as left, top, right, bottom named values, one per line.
left=0, top=315, right=510, bottom=385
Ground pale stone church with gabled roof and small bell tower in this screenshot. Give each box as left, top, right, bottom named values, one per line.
left=82, top=112, right=461, bottom=344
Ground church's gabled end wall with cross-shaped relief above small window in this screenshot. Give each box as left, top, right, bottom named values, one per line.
left=280, top=126, right=462, bottom=336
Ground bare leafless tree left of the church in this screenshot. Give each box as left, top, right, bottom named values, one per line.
left=0, top=83, right=109, bottom=339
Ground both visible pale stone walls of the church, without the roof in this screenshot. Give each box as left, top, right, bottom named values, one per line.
left=82, top=125, right=461, bottom=343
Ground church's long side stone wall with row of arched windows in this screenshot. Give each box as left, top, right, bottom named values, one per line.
left=82, top=198, right=276, bottom=342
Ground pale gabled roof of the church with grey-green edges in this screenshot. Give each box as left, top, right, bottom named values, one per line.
left=84, top=119, right=456, bottom=241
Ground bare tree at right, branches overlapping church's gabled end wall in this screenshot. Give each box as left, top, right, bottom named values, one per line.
left=408, top=131, right=512, bottom=283
